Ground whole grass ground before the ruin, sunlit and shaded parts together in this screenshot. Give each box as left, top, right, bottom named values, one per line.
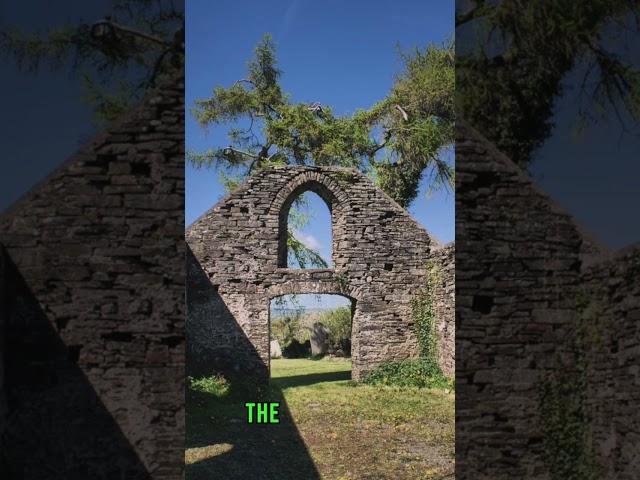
left=185, top=359, right=455, bottom=480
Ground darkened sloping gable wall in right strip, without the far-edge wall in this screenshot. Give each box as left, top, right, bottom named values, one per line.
left=456, top=125, right=582, bottom=480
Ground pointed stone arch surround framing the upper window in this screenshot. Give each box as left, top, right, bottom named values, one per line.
left=270, top=171, right=348, bottom=268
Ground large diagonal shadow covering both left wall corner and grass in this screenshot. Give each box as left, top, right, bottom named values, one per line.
left=185, top=250, right=325, bottom=480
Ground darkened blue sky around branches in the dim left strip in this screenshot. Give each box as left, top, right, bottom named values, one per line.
left=0, top=0, right=109, bottom=212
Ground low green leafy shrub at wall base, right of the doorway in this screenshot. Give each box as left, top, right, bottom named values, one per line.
left=362, top=358, right=454, bottom=389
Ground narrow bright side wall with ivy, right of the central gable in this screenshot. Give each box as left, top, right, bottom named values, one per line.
left=432, top=243, right=456, bottom=376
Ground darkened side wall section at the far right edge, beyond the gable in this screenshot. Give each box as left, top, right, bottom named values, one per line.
left=583, top=245, right=640, bottom=480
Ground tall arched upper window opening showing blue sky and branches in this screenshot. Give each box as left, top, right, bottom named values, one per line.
left=278, top=184, right=333, bottom=269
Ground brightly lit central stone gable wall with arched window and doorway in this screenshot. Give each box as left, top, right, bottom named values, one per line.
left=186, top=167, right=450, bottom=378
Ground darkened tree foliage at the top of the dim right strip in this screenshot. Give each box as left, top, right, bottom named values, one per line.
left=456, top=0, right=640, bottom=168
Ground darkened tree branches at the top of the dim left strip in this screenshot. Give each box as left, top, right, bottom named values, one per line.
left=0, top=0, right=184, bottom=124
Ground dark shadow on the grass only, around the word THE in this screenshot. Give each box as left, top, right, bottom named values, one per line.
left=185, top=381, right=320, bottom=480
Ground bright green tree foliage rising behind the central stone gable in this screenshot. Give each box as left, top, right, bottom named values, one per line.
left=188, top=35, right=454, bottom=206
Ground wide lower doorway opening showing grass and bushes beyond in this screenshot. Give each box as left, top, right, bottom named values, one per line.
left=269, top=294, right=355, bottom=383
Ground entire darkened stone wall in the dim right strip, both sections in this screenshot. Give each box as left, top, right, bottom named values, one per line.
left=456, top=124, right=640, bottom=480
